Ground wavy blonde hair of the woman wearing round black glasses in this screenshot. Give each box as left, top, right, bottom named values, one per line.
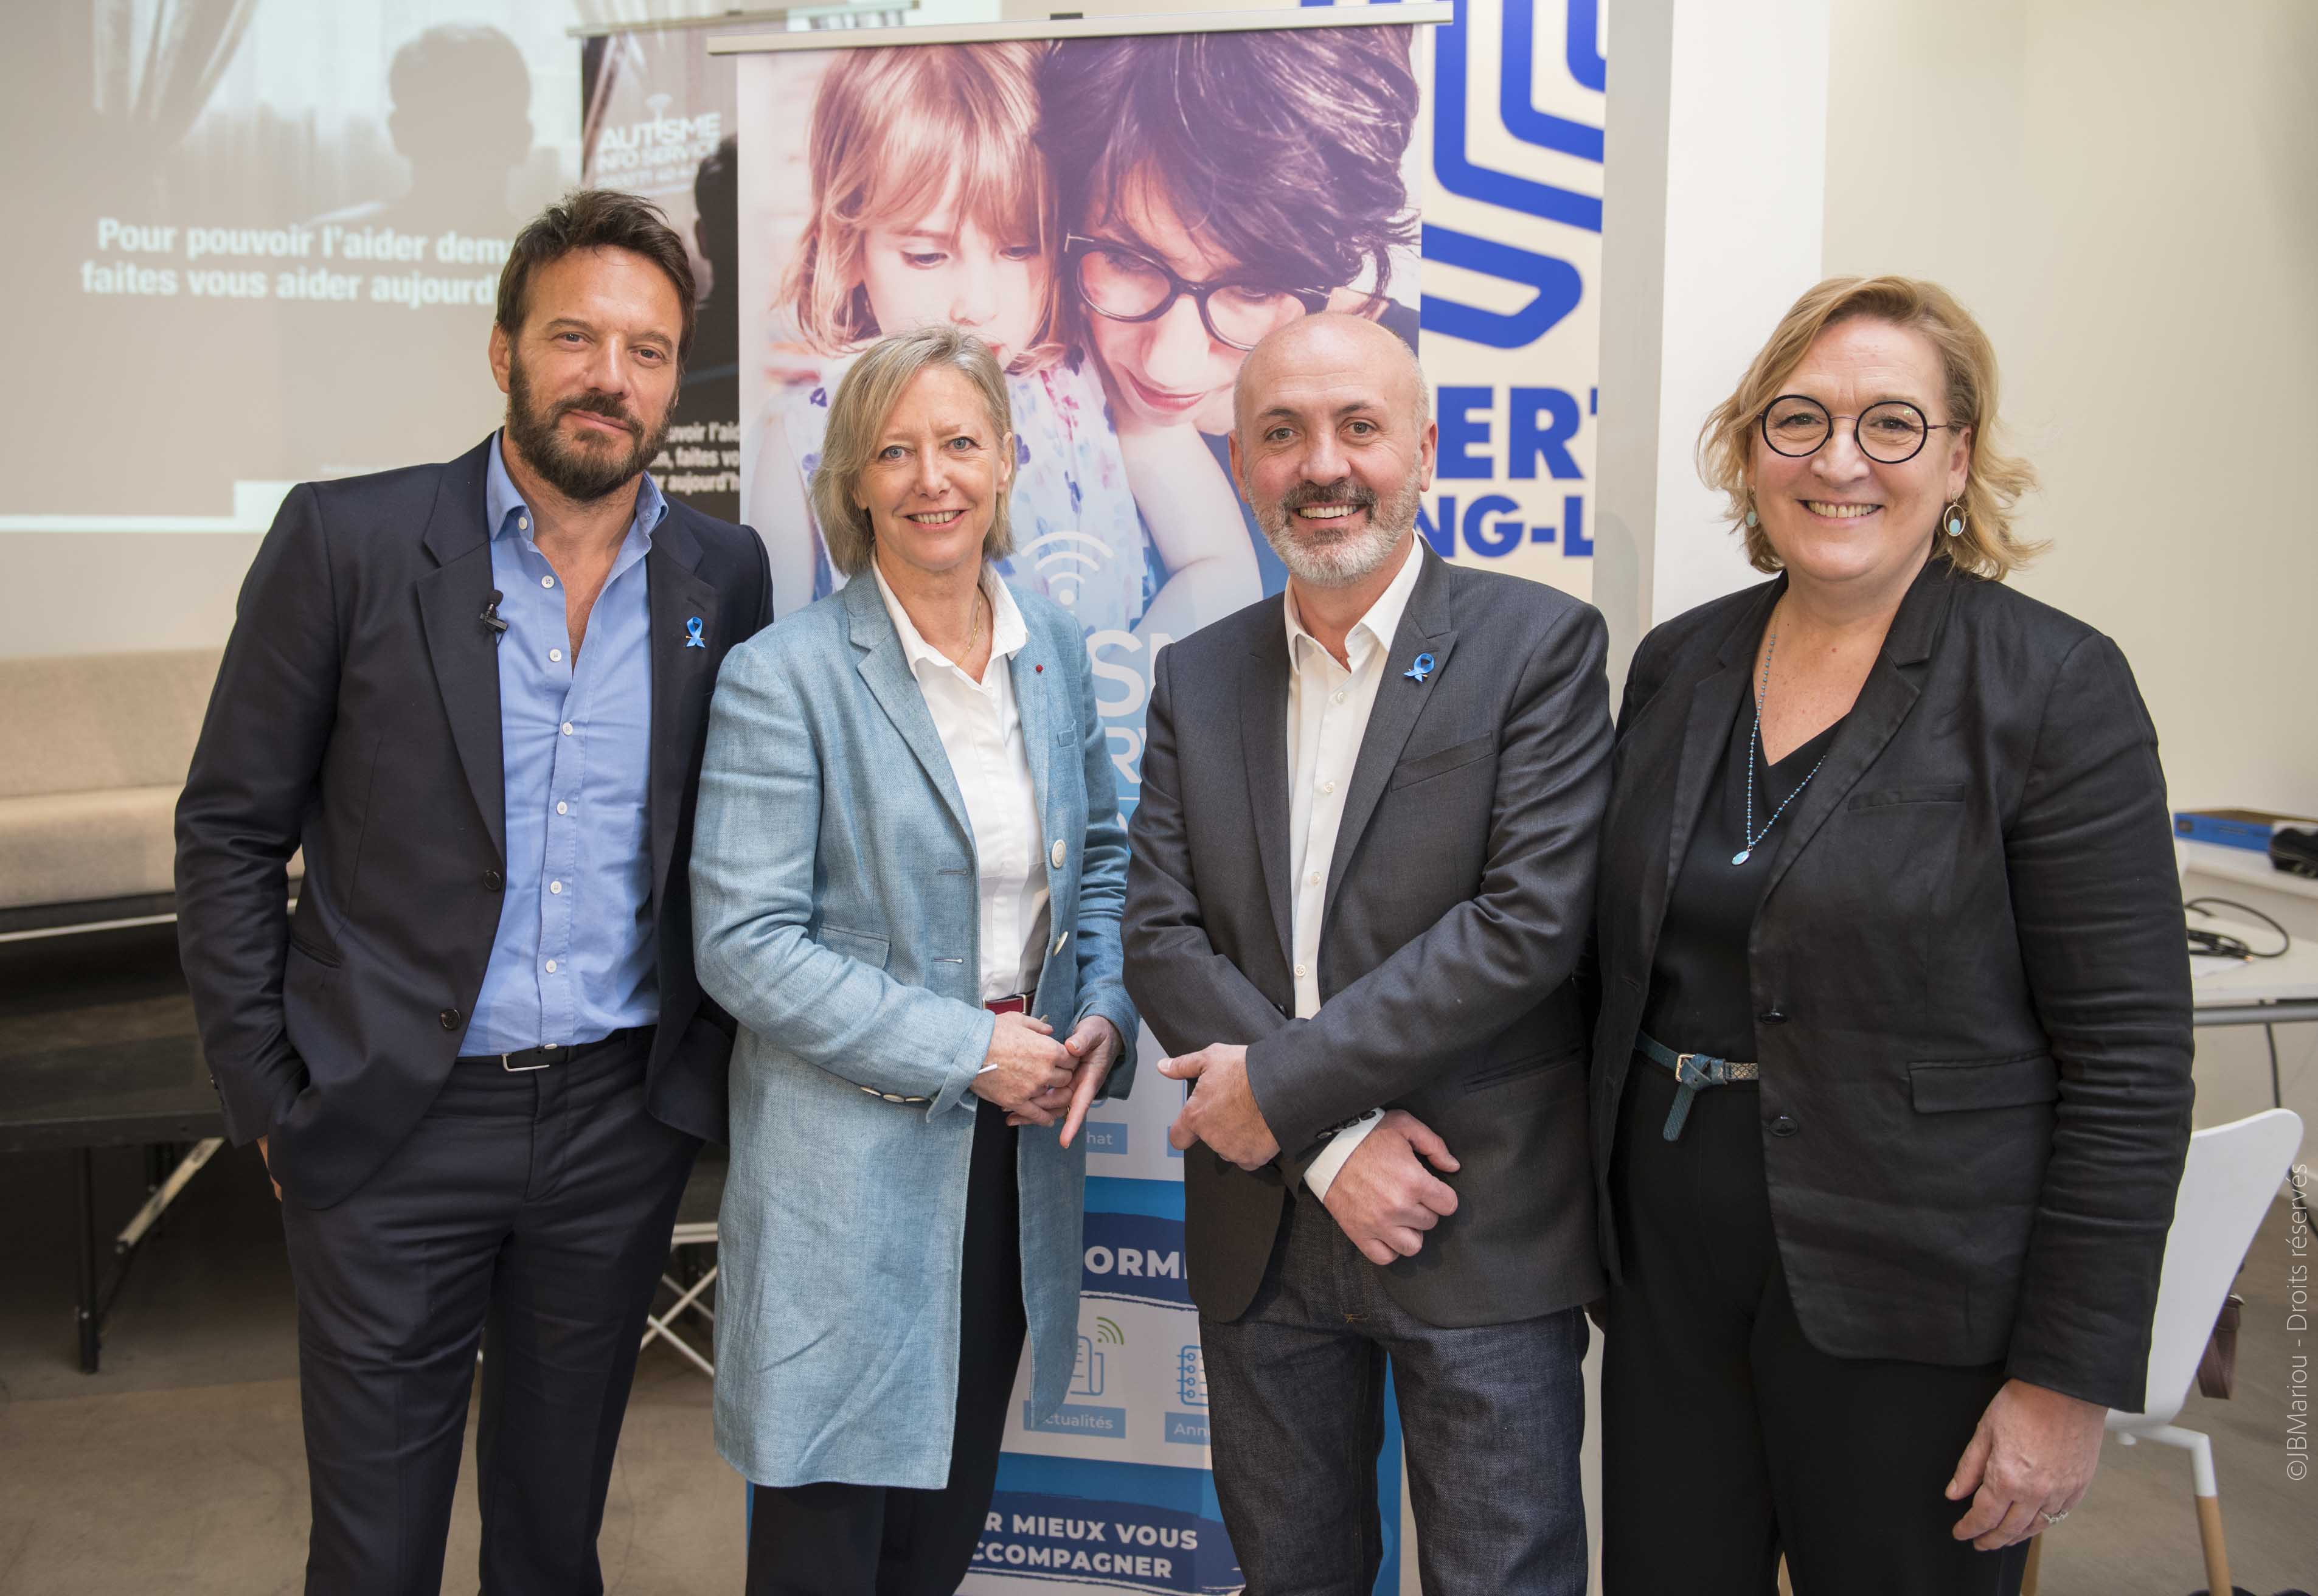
left=1699, top=278, right=2044, bottom=581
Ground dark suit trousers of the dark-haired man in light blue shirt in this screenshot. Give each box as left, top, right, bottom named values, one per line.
left=283, top=1029, right=700, bottom=1596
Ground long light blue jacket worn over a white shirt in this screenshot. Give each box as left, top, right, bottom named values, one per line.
left=693, top=579, right=1136, bottom=1490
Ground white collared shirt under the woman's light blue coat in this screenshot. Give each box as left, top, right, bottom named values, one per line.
left=869, top=561, right=1050, bottom=1003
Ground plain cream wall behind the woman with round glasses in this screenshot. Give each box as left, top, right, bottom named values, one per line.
left=1824, top=0, right=2318, bottom=813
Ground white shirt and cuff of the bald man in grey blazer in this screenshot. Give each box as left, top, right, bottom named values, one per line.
left=1282, top=538, right=1426, bottom=1198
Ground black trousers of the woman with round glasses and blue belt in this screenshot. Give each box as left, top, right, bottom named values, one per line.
left=1601, top=1056, right=2028, bottom=1596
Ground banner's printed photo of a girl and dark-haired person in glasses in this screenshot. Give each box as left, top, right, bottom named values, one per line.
left=737, top=14, right=1426, bottom=806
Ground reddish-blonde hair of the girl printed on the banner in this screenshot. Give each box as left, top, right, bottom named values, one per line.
left=781, top=42, right=1061, bottom=370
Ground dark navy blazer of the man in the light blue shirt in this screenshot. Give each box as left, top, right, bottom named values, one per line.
left=176, top=433, right=772, bottom=1207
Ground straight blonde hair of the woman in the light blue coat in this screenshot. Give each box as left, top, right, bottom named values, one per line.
left=811, top=327, right=1013, bottom=579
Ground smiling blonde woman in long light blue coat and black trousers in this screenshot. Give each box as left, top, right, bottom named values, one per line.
left=693, top=327, right=1136, bottom=1596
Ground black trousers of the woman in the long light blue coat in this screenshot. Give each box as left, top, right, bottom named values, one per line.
left=749, top=1103, right=1024, bottom=1596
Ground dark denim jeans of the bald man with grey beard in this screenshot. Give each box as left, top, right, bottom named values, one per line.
left=1198, top=1193, right=1586, bottom=1596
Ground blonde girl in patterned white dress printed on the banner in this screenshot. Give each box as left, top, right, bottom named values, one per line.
left=749, top=44, right=1254, bottom=633
